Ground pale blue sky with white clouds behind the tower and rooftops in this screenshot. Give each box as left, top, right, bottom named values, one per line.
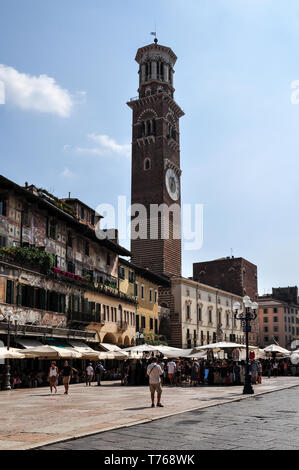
left=0, top=0, right=299, bottom=294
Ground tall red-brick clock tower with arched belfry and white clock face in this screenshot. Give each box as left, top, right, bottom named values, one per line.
left=127, top=39, right=184, bottom=277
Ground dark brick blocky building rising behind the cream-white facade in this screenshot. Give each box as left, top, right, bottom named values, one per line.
left=193, top=256, right=259, bottom=344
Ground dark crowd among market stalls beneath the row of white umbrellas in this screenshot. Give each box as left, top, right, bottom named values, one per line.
left=0, top=355, right=299, bottom=390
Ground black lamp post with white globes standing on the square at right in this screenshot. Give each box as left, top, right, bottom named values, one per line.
left=233, top=295, right=258, bottom=395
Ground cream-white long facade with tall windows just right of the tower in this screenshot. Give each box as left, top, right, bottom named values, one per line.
left=160, top=278, right=245, bottom=348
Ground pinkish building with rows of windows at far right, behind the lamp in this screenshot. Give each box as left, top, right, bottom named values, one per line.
left=258, top=287, right=299, bottom=349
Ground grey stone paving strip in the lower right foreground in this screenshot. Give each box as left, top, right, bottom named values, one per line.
left=41, top=387, right=299, bottom=451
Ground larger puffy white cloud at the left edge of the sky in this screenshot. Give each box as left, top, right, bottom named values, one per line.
left=0, top=64, right=73, bottom=117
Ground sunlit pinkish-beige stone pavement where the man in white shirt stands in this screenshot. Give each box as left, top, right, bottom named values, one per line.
left=0, top=377, right=299, bottom=450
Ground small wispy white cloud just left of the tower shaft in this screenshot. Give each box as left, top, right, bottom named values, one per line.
left=74, top=134, right=131, bottom=157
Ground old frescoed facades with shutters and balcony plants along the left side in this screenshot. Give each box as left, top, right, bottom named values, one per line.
left=0, top=177, right=137, bottom=346
